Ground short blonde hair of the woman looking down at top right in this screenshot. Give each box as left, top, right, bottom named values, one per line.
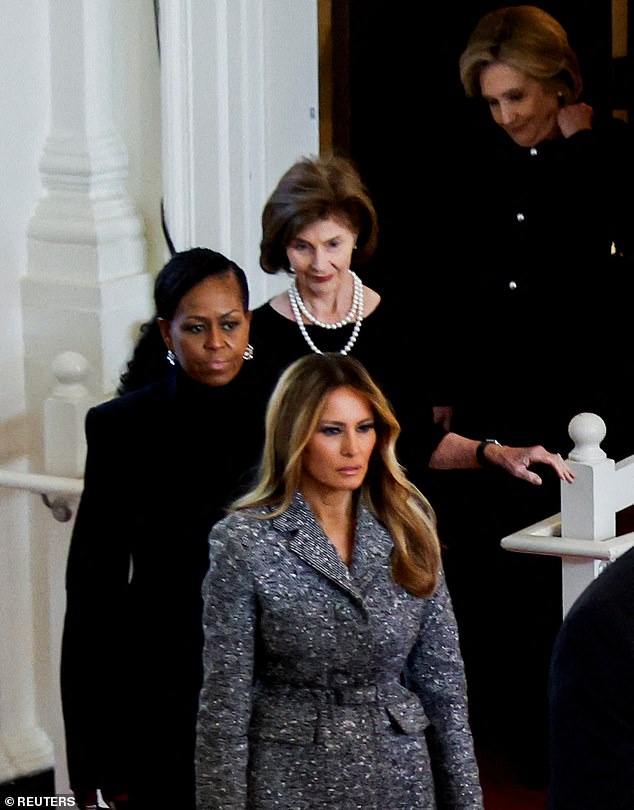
left=460, top=6, right=583, bottom=104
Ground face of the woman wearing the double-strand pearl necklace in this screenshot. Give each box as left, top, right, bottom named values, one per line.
left=286, top=217, right=357, bottom=293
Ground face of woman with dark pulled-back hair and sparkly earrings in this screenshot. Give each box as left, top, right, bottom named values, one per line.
left=159, top=273, right=251, bottom=386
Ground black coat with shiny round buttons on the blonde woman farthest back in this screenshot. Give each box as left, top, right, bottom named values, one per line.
left=446, top=115, right=634, bottom=458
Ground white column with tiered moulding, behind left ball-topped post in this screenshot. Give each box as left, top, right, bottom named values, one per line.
left=22, top=0, right=151, bottom=410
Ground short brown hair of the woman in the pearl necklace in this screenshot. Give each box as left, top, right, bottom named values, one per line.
left=260, top=155, right=378, bottom=273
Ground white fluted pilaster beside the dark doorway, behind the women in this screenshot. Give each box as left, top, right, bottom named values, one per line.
left=160, top=0, right=319, bottom=306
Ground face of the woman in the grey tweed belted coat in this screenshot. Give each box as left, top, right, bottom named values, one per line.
left=300, top=386, right=376, bottom=501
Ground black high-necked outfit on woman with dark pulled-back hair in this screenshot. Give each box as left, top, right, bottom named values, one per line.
left=61, top=363, right=270, bottom=810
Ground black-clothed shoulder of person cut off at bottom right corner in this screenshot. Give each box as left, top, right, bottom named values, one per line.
left=548, top=549, right=634, bottom=810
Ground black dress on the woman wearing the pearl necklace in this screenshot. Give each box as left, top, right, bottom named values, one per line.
left=250, top=299, right=445, bottom=487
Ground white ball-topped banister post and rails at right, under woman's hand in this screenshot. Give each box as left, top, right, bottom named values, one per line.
left=501, top=413, right=634, bottom=615
